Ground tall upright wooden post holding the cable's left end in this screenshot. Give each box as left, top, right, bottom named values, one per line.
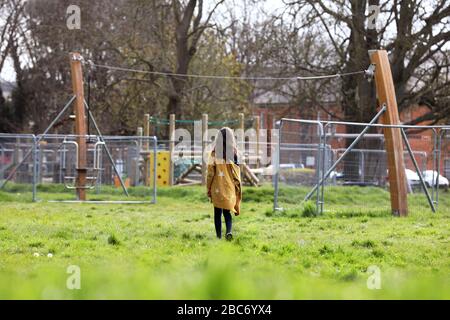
left=70, top=52, right=87, bottom=201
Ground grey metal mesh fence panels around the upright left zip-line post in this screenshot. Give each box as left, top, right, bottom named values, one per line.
left=0, top=134, right=157, bottom=203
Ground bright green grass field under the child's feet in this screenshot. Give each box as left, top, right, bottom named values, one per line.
left=0, top=186, right=450, bottom=299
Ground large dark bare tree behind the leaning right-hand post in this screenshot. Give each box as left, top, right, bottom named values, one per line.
left=289, top=0, right=450, bottom=123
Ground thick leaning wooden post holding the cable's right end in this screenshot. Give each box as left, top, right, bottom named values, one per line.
left=369, top=50, right=408, bottom=216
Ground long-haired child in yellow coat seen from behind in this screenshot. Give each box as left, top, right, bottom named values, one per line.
left=206, top=127, right=242, bottom=240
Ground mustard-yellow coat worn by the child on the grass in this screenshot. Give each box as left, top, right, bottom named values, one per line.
left=206, top=153, right=242, bottom=215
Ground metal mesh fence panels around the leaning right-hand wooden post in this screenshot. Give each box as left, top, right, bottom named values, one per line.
left=274, top=119, right=450, bottom=212
